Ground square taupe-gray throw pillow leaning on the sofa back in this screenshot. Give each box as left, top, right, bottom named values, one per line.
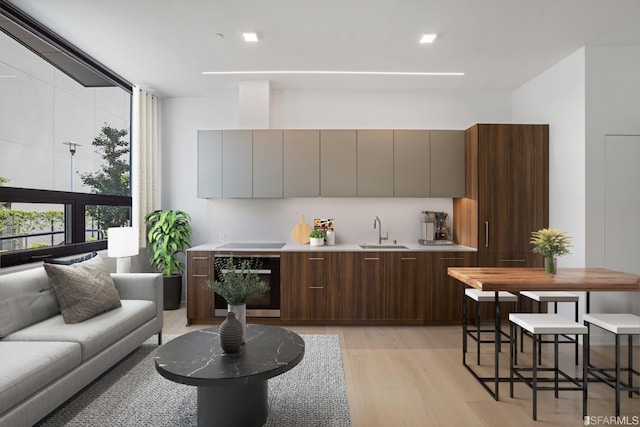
left=44, top=257, right=122, bottom=323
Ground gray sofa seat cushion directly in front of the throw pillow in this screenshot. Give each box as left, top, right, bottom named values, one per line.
left=3, top=300, right=156, bottom=362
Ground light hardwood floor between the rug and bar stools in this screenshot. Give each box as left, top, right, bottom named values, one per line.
left=163, top=308, right=640, bottom=427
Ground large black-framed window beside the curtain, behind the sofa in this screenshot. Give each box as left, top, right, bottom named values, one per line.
left=0, top=2, right=131, bottom=267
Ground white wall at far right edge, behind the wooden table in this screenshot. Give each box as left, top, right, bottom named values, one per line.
left=586, top=46, right=640, bottom=324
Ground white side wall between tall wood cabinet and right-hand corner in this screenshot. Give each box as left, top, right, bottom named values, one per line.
left=512, top=48, right=586, bottom=267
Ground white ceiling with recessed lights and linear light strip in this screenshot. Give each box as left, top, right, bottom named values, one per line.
left=9, top=0, right=640, bottom=97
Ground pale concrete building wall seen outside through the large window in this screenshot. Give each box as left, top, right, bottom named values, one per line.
left=0, top=32, right=131, bottom=192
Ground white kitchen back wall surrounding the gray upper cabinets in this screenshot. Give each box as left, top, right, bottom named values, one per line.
left=161, top=91, right=511, bottom=245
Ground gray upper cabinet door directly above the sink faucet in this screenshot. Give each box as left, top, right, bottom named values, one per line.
left=357, top=130, right=393, bottom=197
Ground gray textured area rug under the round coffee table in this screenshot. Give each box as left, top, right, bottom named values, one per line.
left=39, top=335, right=351, bottom=427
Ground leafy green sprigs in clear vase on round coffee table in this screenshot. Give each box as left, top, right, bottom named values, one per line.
left=206, top=257, right=269, bottom=342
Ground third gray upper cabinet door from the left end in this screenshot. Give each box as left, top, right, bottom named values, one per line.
left=253, top=130, right=283, bottom=198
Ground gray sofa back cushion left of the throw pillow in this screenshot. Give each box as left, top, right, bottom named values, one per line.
left=0, top=267, right=60, bottom=338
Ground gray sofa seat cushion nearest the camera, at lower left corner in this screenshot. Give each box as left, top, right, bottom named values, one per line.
left=0, top=341, right=81, bottom=414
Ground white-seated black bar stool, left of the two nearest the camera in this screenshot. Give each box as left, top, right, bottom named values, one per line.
left=509, top=313, right=589, bottom=420
